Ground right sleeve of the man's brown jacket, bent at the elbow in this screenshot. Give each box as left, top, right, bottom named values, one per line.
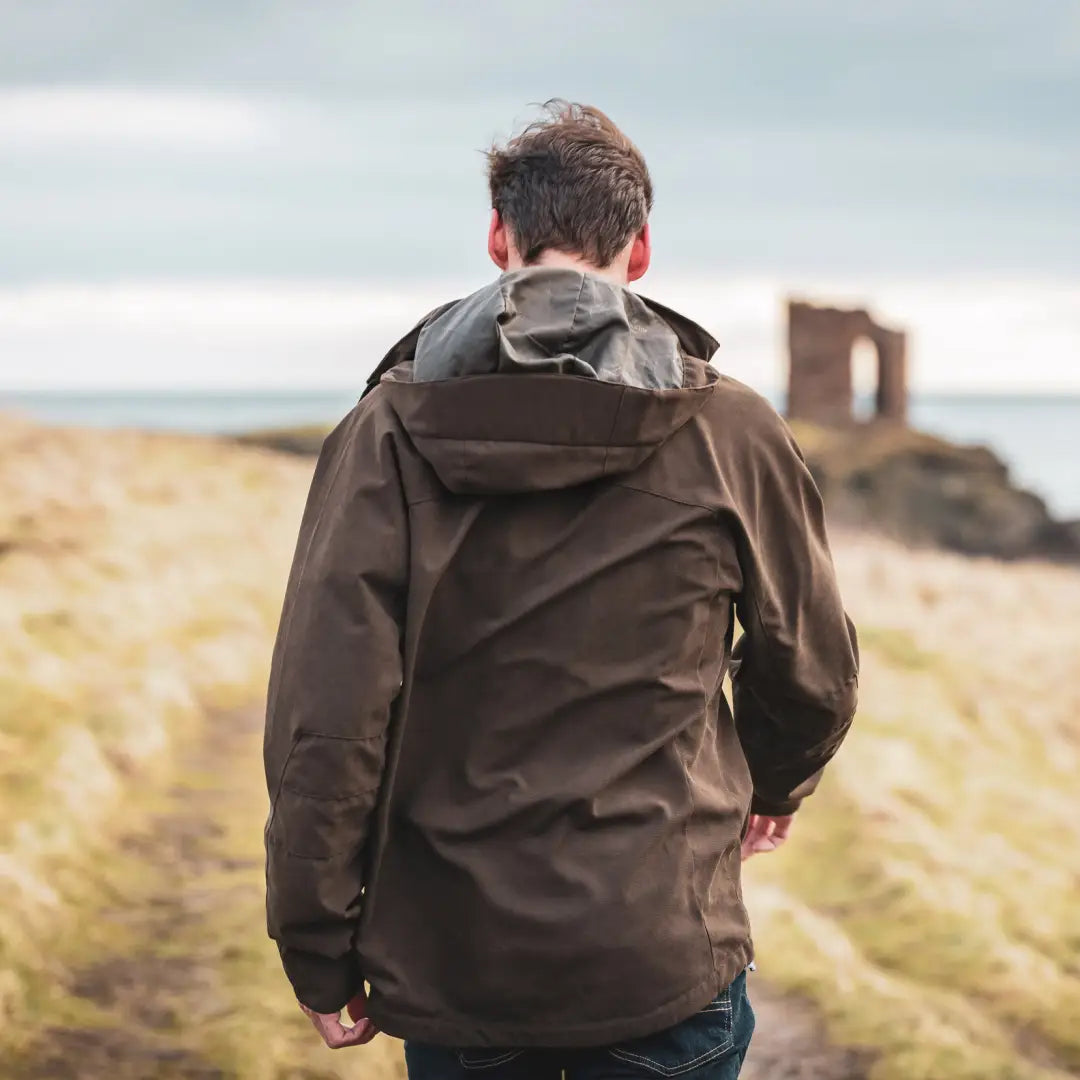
left=732, top=402, right=859, bottom=816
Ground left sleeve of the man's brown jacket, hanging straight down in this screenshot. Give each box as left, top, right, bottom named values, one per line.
left=264, top=396, right=408, bottom=1012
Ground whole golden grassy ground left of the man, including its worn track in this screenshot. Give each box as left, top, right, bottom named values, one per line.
left=0, top=418, right=402, bottom=1080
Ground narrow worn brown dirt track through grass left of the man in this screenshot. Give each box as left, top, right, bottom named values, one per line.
left=3, top=713, right=258, bottom=1080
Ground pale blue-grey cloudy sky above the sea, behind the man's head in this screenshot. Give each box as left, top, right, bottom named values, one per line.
left=0, top=0, right=1080, bottom=392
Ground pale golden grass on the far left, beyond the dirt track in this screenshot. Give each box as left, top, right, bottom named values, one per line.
left=0, top=418, right=309, bottom=1048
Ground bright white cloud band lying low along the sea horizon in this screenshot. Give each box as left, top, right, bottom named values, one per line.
left=0, top=274, right=1080, bottom=393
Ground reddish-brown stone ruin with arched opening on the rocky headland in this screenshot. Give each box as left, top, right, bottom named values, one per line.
left=787, top=300, right=907, bottom=427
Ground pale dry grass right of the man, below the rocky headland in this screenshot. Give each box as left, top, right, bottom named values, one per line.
left=747, top=540, right=1080, bottom=1080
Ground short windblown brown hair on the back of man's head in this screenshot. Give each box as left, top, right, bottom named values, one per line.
left=487, top=98, right=652, bottom=268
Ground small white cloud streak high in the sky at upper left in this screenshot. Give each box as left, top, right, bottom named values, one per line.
left=0, top=86, right=280, bottom=152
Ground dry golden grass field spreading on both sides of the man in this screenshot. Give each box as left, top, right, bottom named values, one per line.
left=0, top=418, right=1080, bottom=1080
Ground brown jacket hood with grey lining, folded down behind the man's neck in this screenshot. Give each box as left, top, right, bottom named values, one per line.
left=380, top=267, right=718, bottom=495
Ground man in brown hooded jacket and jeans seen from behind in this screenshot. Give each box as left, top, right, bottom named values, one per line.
left=266, top=103, right=858, bottom=1080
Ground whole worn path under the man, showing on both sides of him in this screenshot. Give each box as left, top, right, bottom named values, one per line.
left=0, top=711, right=865, bottom=1080
